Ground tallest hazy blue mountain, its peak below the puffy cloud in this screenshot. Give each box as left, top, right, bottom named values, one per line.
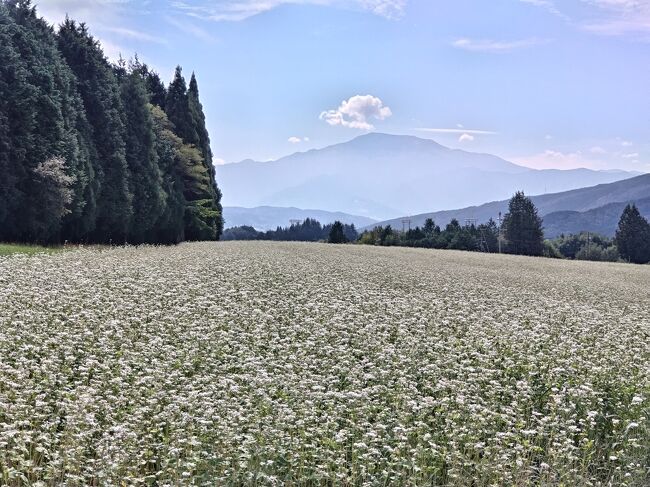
left=217, top=133, right=632, bottom=219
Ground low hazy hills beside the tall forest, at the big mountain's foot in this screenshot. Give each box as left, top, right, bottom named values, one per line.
left=223, top=206, right=375, bottom=231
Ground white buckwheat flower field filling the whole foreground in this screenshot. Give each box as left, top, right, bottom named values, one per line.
left=0, top=242, right=650, bottom=487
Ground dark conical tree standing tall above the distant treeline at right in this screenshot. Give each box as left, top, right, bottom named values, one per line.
left=503, top=191, right=544, bottom=255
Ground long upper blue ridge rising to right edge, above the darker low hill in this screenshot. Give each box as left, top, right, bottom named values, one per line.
left=373, top=174, right=650, bottom=236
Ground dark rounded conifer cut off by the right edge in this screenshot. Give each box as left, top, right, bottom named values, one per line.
left=614, top=205, right=650, bottom=264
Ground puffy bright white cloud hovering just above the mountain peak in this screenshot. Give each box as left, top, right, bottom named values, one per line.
left=319, top=95, right=393, bottom=130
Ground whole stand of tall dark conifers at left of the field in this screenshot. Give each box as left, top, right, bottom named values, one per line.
left=0, top=0, right=223, bottom=244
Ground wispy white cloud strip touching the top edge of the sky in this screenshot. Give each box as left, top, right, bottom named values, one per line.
left=171, top=0, right=408, bottom=21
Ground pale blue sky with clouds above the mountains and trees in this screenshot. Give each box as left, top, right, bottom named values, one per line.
left=35, top=0, right=650, bottom=172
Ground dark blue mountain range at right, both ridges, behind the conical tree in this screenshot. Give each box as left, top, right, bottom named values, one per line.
left=371, top=174, right=650, bottom=238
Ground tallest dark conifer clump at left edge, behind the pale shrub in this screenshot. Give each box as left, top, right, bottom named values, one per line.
left=0, top=1, right=96, bottom=243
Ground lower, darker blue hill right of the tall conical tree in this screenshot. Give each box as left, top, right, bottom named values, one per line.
left=544, top=197, right=650, bottom=238
